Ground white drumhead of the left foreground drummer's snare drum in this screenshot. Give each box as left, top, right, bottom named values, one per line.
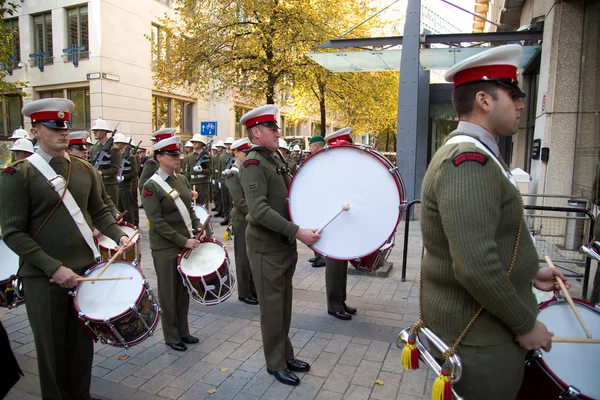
left=75, top=261, right=144, bottom=320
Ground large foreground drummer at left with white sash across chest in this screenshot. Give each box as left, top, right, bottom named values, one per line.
left=0, top=98, right=133, bottom=400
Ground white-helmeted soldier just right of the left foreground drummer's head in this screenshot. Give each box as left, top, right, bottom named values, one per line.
left=90, top=118, right=121, bottom=208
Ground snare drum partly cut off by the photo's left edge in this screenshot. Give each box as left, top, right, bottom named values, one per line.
left=0, top=236, right=25, bottom=308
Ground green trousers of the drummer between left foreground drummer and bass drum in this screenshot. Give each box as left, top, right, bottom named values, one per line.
left=152, top=247, right=190, bottom=344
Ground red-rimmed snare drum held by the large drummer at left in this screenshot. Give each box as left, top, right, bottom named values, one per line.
left=73, top=260, right=160, bottom=348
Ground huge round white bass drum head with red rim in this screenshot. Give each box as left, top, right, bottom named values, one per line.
left=289, top=146, right=402, bottom=260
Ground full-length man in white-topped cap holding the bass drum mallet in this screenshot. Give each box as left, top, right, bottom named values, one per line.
left=240, top=105, right=320, bottom=386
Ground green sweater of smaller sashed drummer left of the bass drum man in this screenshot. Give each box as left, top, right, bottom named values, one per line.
left=142, top=169, right=201, bottom=250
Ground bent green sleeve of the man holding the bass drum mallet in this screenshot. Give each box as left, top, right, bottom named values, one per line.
left=240, top=165, right=299, bottom=238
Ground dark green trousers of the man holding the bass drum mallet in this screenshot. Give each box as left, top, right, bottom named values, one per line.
left=246, top=244, right=298, bottom=371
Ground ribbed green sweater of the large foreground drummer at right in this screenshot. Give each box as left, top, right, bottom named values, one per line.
left=421, top=121, right=539, bottom=346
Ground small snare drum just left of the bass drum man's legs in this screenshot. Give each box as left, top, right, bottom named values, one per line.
left=177, top=239, right=235, bottom=306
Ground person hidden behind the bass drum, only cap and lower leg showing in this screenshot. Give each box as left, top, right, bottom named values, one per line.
left=324, top=128, right=356, bottom=320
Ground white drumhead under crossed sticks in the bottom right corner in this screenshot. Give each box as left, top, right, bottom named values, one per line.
left=538, top=301, right=600, bottom=399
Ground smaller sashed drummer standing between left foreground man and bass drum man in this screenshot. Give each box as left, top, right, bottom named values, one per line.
left=142, top=136, right=201, bottom=351
